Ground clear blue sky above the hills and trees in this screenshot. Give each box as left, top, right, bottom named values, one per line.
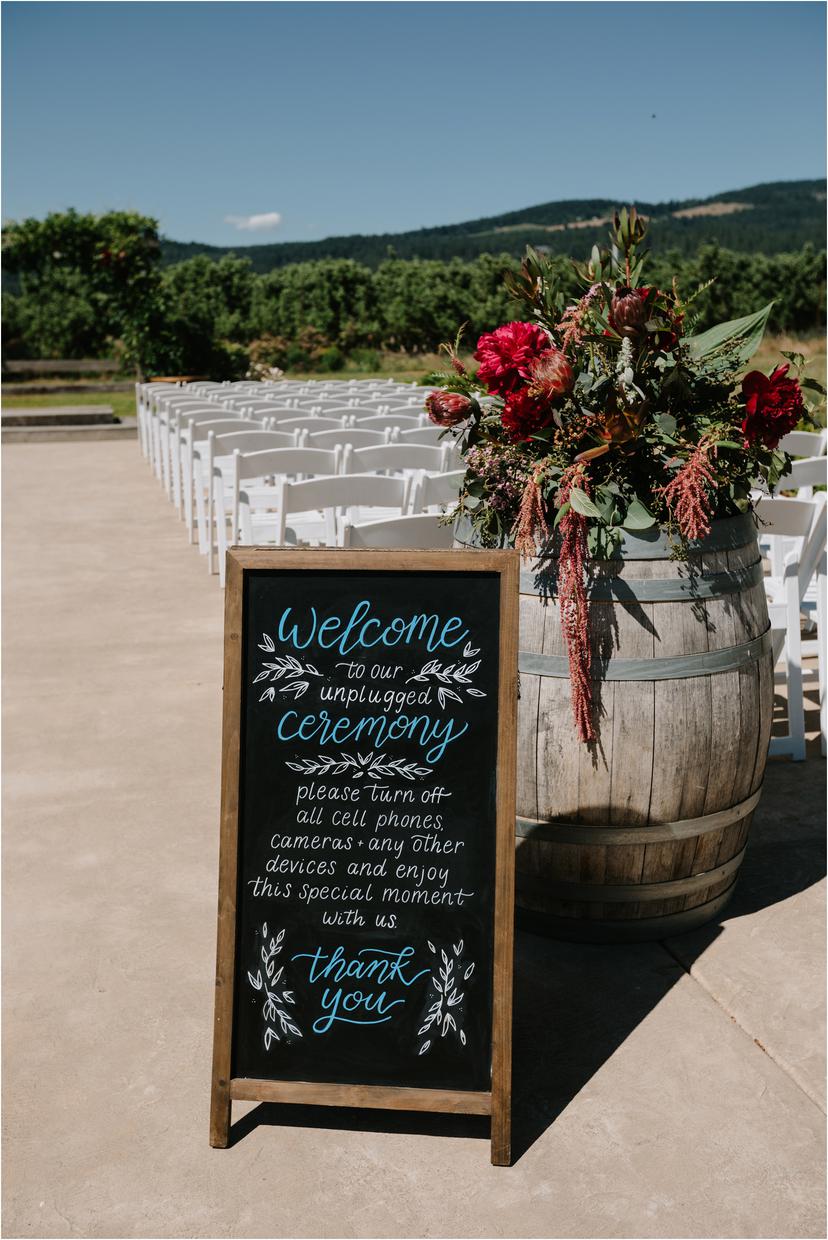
left=2, top=0, right=826, bottom=246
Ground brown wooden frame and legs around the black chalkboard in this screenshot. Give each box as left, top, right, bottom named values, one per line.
left=209, top=547, right=519, bottom=1166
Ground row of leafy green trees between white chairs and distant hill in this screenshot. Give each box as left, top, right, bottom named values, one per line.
left=4, top=207, right=826, bottom=372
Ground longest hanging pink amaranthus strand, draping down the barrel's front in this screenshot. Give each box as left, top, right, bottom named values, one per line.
left=558, top=465, right=596, bottom=743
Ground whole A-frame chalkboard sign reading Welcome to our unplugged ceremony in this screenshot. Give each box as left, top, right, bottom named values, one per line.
left=211, top=547, right=518, bottom=1166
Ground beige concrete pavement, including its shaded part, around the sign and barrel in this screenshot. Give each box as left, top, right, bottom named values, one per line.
left=2, top=443, right=824, bottom=1238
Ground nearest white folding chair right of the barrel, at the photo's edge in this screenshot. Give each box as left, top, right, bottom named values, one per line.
left=755, top=494, right=826, bottom=761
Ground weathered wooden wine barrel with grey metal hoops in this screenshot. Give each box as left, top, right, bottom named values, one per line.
left=517, top=516, right=773, bottom=941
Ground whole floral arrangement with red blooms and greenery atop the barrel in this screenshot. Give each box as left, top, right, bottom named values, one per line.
left=426, top=207, right=824, bottom=742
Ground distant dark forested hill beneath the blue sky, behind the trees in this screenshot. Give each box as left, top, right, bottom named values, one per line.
left=162, top=180, right=826, bottom=272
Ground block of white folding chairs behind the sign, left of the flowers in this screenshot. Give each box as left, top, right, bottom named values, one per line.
left=136, top=382, right=462, bottom=583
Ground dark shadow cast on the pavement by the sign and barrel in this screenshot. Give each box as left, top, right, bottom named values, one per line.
left=231, top=759, right=826, bottom=1162
